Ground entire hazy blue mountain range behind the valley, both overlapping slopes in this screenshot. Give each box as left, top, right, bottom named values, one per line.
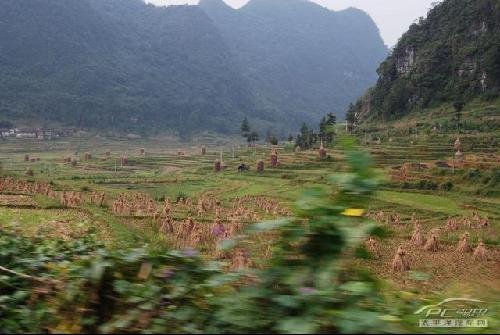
left=0, top=0, right=386, bottom=133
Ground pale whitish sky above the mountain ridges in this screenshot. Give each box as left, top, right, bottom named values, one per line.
left=147, top=0, right=437, bottom=46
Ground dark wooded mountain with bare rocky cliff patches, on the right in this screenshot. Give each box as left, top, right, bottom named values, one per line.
left=348, top=0, right=500, bottom=122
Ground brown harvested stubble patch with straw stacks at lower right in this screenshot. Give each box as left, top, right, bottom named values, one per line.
left=355, top=211, right=500, bottom=289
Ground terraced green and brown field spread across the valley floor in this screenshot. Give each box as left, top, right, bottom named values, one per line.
left=0, top=107, right=500, bottom=332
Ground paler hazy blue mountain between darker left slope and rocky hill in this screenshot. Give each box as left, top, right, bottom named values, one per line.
left=200, top=0, right=388, bottom=130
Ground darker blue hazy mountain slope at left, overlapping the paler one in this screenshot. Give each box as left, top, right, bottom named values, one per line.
left=0, top=0, right=253, bottom=132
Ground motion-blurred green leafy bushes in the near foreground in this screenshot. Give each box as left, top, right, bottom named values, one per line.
left=0, top=143, right=394, bottom=333
